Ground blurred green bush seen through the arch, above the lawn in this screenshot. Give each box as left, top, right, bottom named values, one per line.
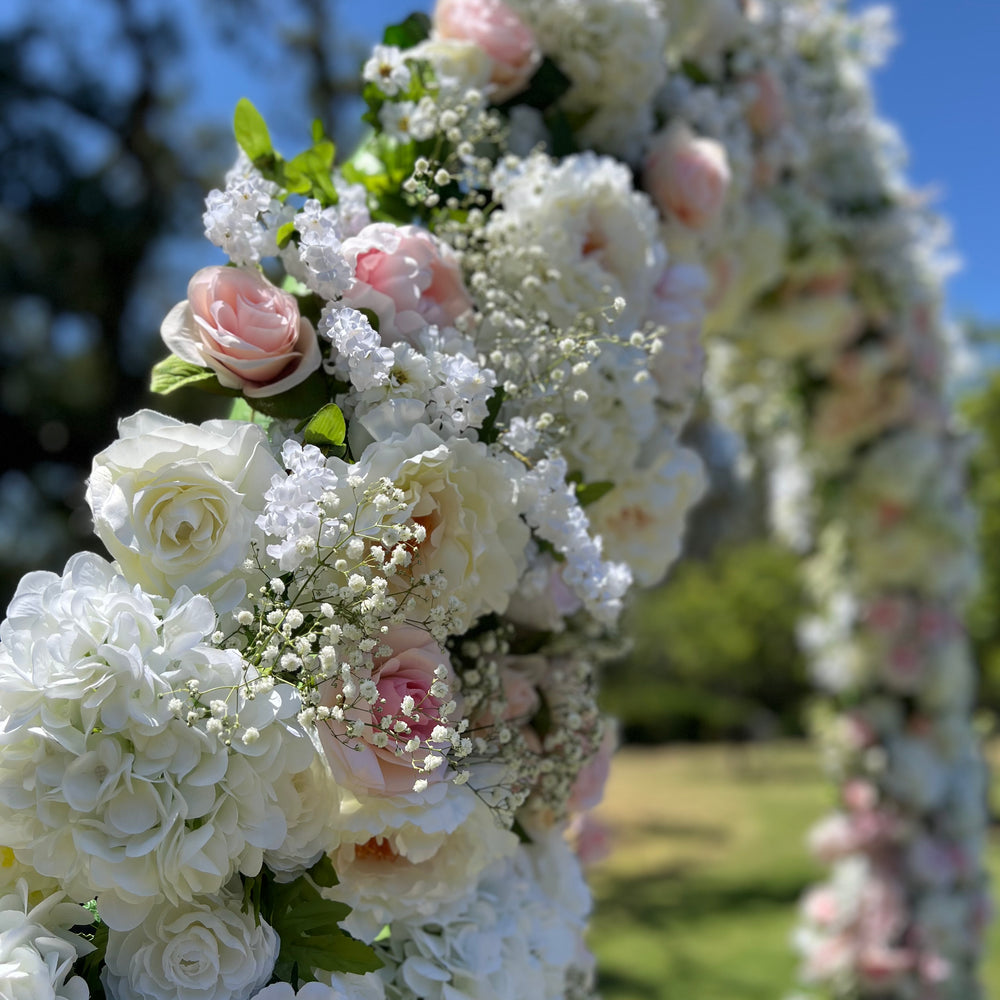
left=604, top=541, right=809, bottom=742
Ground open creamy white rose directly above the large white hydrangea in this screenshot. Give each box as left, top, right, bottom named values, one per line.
left=87, top=410, right=282, bottom=608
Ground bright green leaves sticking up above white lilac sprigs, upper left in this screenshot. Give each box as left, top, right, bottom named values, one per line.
left=233, top=97, right=337, bottom=209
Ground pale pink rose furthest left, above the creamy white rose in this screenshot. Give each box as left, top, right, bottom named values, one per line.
left=160, top=267, right=321, bottom=398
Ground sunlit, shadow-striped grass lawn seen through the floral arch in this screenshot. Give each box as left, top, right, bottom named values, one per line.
left=590, top=744, right=1000, bottom=1000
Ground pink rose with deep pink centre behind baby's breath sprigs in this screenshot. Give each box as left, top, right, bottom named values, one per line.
left=320, top=625, right=454, bottom=795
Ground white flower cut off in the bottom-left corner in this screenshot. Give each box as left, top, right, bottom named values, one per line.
left=0, top=879, right=94, bottom=1000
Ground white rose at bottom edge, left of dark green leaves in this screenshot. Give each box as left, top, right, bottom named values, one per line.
left=102, top=899, right=278, bottom=1000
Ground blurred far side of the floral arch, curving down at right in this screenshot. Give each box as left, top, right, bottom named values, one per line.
left=643, top=0, right=985, bottom=1000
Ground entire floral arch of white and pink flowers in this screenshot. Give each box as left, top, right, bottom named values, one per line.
left=0, top=0, right=984, bottom=1000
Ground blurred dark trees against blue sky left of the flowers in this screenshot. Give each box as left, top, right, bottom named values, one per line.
left=0, top=0, right=355, bottom=606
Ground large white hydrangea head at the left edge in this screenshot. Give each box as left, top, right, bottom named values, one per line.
left=0, top=553, right=315, bottom=929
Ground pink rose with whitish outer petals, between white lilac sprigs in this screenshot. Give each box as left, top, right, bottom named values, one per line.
left=341, top=222, right=472, bottom=345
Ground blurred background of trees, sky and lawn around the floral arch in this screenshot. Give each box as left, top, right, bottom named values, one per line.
left=0, top=0, right=1000, bottom=1000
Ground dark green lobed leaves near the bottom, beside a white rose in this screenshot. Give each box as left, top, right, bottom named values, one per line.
left=243, top=856, right=383, bottom=989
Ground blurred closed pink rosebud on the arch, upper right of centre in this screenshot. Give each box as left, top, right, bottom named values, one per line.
left=642, top=121, right=731, bottom=230
